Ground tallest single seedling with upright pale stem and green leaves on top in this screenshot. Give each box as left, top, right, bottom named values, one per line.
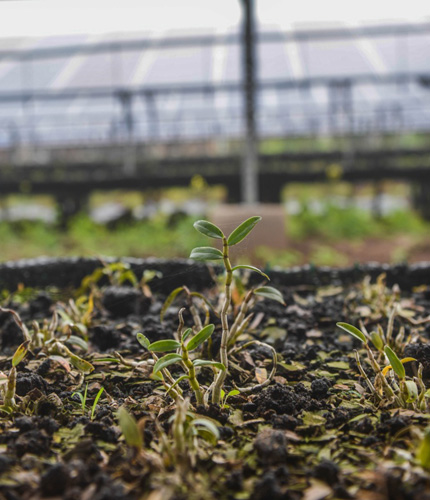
left=190, top=216, right=283, bottom=404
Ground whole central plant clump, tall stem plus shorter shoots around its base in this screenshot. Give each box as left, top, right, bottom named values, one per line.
left=137, top=216, right=285, bottom=404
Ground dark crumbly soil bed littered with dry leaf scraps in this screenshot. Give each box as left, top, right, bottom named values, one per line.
left=0, top=259, right=430, bottom=500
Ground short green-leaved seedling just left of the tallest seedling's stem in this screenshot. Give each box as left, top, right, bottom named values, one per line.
left=137, top=309, right=225, bottom=404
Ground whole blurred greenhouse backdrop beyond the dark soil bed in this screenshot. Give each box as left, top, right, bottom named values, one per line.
left=0, top=0, right=430, bottom=266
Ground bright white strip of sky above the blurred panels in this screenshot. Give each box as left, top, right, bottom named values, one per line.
left=0, top=0, right=430, bottom=37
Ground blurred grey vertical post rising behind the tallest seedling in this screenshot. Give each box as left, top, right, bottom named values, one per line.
left=241, top=0, right=259, bottom=204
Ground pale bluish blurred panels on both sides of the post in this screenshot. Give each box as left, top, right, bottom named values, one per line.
left=0, top=24, right=430, bottom=147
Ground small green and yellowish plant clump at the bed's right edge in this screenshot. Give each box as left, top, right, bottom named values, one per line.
left=337, top=323, right=430, bottom=411
